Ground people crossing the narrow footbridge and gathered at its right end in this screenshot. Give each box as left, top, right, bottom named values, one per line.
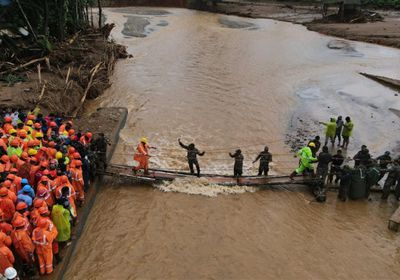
left=133, top=116, right=400, bottom=200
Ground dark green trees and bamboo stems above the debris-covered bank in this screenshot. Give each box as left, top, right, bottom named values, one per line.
left=0, top=0, right=101, bottom=61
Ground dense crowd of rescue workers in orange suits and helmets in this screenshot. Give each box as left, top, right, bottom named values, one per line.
left=0, top=108, right=108, bottom=279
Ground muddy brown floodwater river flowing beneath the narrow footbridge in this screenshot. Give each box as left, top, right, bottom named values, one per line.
left=65, top=8, right=400, bottom=279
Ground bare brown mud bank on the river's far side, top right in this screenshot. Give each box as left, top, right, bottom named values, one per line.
left=209, top=1, right=400, bottom=48
